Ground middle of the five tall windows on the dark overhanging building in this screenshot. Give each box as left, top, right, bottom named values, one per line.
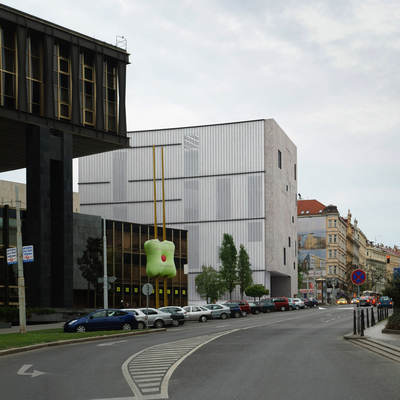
left=55, top=44, right=72, bottom=119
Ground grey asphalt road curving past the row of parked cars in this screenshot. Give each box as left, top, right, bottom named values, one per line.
left=0, top=307, right=400, bottom=400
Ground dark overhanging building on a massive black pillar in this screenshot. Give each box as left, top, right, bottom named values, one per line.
left=0, top=4, right=129, bottom=307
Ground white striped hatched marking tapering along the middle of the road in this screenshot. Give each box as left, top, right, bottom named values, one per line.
left=122, top=329, right=237, bottom=400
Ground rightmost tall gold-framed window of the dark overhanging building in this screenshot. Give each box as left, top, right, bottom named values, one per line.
left=104, top=62, right=118, bottom=132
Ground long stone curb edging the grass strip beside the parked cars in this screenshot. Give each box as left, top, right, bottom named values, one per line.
left=0, top=328, right=167, bottom=357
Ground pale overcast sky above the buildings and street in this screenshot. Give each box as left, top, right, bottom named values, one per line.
left=0, top=0, right=400, bottom=245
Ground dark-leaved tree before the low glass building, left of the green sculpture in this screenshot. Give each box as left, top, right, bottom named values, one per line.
left=77, top=237, right=104, bottom=307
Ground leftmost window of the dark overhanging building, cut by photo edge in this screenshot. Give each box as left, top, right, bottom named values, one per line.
left=0, top=27, right=18, bottom=109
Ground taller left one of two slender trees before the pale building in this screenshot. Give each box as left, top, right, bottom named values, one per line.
left=219, top=233, right=238, bottom=300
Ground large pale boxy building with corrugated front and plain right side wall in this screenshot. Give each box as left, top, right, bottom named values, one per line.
left=79, top=119, right=297, bottom=302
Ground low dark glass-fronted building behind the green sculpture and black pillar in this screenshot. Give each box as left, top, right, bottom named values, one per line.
left=0, top=205, right=188, bottom=308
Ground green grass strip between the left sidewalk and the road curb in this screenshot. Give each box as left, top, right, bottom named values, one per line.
left=0, top=328, right=135, bottom=350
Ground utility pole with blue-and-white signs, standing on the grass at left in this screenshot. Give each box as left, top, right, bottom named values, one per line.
left=15, top=185, right=26, bottom=333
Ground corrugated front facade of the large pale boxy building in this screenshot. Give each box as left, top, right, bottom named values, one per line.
left=79, top=120, right=296, bottom=302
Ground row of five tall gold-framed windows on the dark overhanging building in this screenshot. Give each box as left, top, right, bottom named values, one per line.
left=0, top=27, right=118, bottom=132
